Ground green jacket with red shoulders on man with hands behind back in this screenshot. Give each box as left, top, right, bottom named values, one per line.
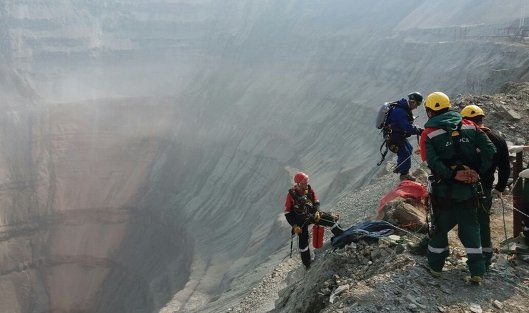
left=422, top=111, right=496, bottom=201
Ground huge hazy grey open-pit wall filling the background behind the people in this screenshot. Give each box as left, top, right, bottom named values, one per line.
left=0, top=0, right=529, bottom=313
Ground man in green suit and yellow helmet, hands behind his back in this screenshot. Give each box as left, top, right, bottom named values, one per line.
left=420, top=92, right=496, bottom=284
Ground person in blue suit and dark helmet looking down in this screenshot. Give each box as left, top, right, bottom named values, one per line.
left=386, top=92, right=423, bottom=181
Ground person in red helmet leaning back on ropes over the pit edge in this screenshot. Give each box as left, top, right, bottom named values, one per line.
left=285, top=172, right=343, bottom=270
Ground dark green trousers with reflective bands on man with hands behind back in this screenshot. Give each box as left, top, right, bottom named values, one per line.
left=427, top=202, right=485, bottom=276
